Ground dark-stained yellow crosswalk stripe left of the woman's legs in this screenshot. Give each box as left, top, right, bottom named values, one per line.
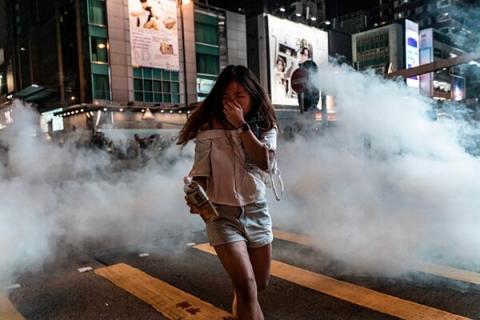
left=95, top=263, right=233, bottom=320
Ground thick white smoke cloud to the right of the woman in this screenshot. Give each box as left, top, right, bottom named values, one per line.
left=272, top=62, right=480, bottom=274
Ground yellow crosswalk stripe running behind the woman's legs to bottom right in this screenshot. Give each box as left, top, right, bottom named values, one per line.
left=194, top=243, right=469, bottom=320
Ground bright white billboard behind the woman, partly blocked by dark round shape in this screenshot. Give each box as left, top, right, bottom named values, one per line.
left=267, top=15, right=328, bottom=106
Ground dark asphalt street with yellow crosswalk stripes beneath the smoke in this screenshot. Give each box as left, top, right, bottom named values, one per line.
left=0, top=230, right=480, bottom=320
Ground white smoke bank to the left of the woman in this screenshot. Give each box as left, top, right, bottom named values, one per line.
left=0, top=102, right=201, bottom=287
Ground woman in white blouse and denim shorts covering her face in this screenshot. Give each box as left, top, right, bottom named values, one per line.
left=178, top=66, right=277, bottom=320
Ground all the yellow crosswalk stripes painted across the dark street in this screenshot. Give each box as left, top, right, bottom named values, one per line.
left=0, top=230, right=480, bottom=320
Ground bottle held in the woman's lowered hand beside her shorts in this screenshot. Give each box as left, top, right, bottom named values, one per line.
left=183, top=177, right=218, bottom=223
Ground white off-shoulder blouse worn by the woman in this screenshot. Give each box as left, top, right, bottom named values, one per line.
left=190, top=128, right=277, bottom=206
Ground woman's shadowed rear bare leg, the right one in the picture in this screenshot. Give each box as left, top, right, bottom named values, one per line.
left=248, top=243, right=272, bottom=292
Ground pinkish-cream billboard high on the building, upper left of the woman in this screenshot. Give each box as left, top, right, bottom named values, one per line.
left=128, top=0, right=180, bottom=71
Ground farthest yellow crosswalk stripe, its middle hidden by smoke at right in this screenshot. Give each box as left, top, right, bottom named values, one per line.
left=273, top=230, right=480, bottom=285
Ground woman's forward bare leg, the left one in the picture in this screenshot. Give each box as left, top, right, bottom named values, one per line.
left=214, top=241, right=263, bottom=320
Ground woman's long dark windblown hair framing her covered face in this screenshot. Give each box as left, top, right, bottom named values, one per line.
left=177, top=65, right=278, bottom=145
